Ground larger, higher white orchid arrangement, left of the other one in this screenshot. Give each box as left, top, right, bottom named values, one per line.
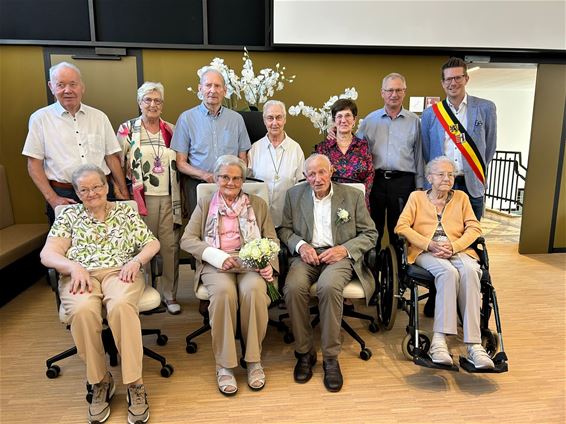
left=187, top=47, right=296, bottom=110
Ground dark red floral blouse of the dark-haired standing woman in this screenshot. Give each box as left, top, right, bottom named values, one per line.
left=314, top=136, right=375, bottom=210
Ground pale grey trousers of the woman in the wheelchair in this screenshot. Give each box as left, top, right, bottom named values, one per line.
left=415, top=252, right=481, bottom=343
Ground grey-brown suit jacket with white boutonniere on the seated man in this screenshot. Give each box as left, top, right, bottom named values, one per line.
left=278, top=183, right=377, bottom=302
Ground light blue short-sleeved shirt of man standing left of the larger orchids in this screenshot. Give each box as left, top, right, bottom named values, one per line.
left=171, top=103, right=251, bottom=172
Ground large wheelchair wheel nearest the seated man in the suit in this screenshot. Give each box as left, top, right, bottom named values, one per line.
left=377, top=246, right=399, bottom=330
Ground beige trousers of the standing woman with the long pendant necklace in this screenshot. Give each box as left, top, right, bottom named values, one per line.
left=143, top=196, right=180, bottom=300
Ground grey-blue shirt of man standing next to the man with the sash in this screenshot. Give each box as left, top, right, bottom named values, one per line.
left=356, top=108, right=424, bottom=188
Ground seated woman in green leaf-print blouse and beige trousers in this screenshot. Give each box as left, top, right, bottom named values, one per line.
left=41, top=164, right=159, bottom=423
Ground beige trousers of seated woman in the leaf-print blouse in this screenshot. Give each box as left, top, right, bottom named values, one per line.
left=59, top=268, right=145, bottom=384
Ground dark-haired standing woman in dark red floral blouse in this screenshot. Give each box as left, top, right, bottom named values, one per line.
left=314, top=99, right=375, bottom=209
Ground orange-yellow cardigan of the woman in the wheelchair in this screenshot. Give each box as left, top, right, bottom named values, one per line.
left=395, top=190, right=482, bottom=264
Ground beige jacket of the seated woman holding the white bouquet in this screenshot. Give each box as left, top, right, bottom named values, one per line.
left=181, top=194, right=279, bottom=292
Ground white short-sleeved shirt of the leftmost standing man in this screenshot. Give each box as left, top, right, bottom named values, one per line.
left=22, top=102, right=122, bottom=183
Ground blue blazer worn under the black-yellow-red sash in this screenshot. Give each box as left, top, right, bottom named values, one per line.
left=421, top=95, right=497, bottom=197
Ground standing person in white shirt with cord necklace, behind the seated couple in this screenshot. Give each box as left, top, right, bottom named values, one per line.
left=248, top=100, right=305, bottom=228
